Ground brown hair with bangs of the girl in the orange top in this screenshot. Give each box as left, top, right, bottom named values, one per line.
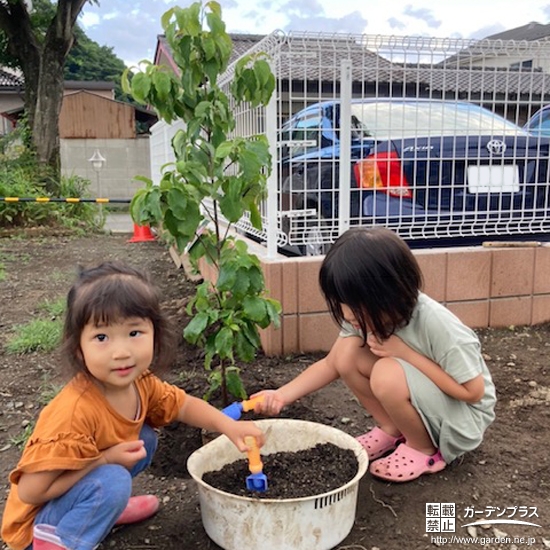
left=62, top=262, right=176, bottom=380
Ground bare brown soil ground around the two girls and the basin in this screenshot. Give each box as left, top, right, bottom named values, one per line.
left=0, top=235, right=550, bottom=550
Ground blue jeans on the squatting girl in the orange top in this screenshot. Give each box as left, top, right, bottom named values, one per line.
left=27, top=425, right=158, bottom=550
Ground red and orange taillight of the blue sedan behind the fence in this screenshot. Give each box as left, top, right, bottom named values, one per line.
left=354, top=152, right=412, bottom=199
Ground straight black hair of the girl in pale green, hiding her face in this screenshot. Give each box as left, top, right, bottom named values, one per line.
left=319, top=227, right=422, bottom=340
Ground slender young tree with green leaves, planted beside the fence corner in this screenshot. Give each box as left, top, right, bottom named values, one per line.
left=123, top=1, right=281, bottom=403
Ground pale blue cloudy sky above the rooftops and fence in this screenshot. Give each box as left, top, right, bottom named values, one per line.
left=79, top=0, right=550, bottom=65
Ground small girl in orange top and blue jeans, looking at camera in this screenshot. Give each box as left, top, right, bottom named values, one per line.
left=2, top=263, right=264, bottom=550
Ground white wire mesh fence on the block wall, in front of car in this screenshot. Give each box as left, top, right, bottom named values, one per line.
left=218, top=32, right=550, bottom=255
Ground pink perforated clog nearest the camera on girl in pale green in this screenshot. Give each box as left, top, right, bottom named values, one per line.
left=369, top=443, right=447, bottom=482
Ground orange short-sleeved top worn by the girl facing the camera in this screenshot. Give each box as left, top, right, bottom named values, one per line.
left=2, top=372, right=185, bottom=550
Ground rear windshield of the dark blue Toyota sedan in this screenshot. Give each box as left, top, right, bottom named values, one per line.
left=351, top=101, right=524, bottom=139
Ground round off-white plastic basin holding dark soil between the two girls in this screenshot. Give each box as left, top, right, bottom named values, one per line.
left=187, top=419, right=374, bottom=550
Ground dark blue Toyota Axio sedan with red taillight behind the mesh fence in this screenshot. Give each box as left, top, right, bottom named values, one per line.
left=280, top=98, right=550, bottom=253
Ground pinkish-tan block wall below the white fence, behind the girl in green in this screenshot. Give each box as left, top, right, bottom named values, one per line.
left=261, top=245, right=550, bottom=355
